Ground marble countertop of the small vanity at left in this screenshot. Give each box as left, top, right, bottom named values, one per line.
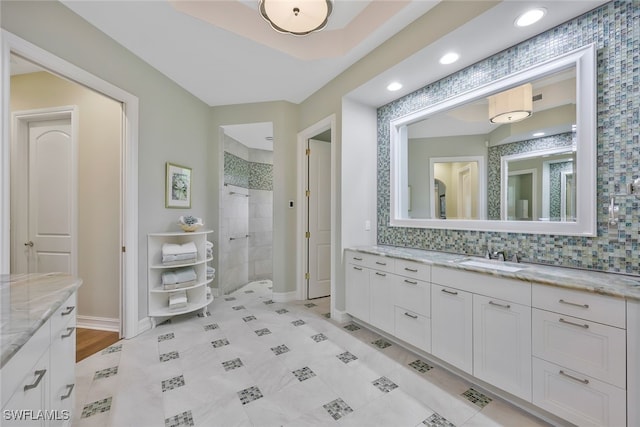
left=0, top=273, right=82, bottom=368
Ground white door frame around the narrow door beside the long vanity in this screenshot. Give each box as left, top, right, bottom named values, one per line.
left=296, top=114, right=338, bottom=306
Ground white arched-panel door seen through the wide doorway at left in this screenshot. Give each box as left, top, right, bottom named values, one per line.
left=14, top=117, right=76, bottom=274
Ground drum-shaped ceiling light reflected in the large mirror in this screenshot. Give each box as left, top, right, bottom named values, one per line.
left=488, top=83, right=533, bottom=123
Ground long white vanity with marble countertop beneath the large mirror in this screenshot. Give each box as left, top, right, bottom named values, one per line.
left=345, top=246, right=640, bottom=427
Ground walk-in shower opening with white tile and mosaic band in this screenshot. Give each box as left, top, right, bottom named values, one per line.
left=216, top=122, right=274, bottom=295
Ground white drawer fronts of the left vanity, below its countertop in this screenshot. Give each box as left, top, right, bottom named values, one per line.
left=2, top=292, right=76, bottom=426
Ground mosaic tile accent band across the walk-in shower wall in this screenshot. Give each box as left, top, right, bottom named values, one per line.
left=224, top=151, right=273, bottom=191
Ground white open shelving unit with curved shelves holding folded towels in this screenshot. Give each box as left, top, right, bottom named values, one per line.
left=147, top=230, right=213, bottom=328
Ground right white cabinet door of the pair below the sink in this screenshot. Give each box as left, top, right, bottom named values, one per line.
left=473, top=295, right=531, bottom=401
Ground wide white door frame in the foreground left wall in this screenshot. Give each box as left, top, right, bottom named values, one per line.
left=0, top=30, right=140, bottom=338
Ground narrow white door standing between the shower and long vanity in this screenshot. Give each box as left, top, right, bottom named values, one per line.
left=307, top=139, right=331, bottom=299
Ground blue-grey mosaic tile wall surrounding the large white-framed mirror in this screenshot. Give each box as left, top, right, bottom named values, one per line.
left=377, top=0, right=640, bottom=275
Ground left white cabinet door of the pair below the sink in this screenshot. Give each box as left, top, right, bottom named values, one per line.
left=431, top=284, right=473, bottom=374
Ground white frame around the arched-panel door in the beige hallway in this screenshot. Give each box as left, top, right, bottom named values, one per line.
left=11, top=105, right=78, bottom=276
